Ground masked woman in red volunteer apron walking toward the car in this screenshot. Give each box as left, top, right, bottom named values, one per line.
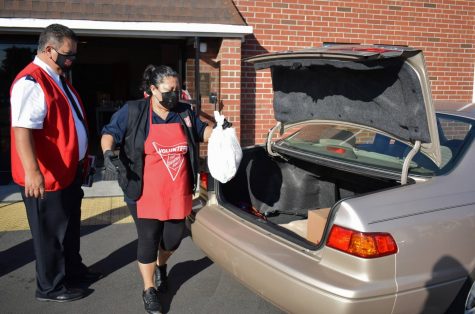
left=101, top=66, right=218, bottom=313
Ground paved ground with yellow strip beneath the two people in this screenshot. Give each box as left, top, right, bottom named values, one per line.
left=0, top=181, right=285, bottom=314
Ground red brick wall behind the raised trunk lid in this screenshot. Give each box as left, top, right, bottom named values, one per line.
left=234, top=0, right=475, bottom=145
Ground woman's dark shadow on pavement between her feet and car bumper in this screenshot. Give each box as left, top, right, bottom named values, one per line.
left=160, top=257, right=213, bottom=313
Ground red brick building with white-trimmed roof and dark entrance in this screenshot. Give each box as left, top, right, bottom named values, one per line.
left=0, top=0, right=475, bottom=179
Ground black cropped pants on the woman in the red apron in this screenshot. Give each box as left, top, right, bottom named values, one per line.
left=127, top=203, right=186, bottom=264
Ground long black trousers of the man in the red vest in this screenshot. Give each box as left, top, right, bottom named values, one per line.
left=21, top=169, right=86, bottom=296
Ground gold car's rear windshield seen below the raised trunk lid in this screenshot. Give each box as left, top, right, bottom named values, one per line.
left=275, top=114, right=473, bottom=176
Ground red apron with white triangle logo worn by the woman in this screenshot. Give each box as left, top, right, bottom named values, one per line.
left=137, top=106, right=192, bottom=221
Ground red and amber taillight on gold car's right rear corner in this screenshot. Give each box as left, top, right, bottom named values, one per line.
left=327, top=225, right=397, bottom=258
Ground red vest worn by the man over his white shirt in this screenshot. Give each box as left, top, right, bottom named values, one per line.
left=10, top=63, right=87, bottom=191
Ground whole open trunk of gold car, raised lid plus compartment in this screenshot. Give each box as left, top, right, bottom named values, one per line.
left=208, top=45, right=442, bottom=247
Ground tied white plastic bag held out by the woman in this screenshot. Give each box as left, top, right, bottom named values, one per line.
left=208, top=111, right=242, bottom=183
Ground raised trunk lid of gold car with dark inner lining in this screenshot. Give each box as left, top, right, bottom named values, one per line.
left=246, top=45, right=441, bottom=166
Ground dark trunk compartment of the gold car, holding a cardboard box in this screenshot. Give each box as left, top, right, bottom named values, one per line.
left=217, top=146, right=400, bottom=247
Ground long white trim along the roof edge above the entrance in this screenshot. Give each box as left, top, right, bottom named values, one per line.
left=0, top=18, right=253, bottom=39
